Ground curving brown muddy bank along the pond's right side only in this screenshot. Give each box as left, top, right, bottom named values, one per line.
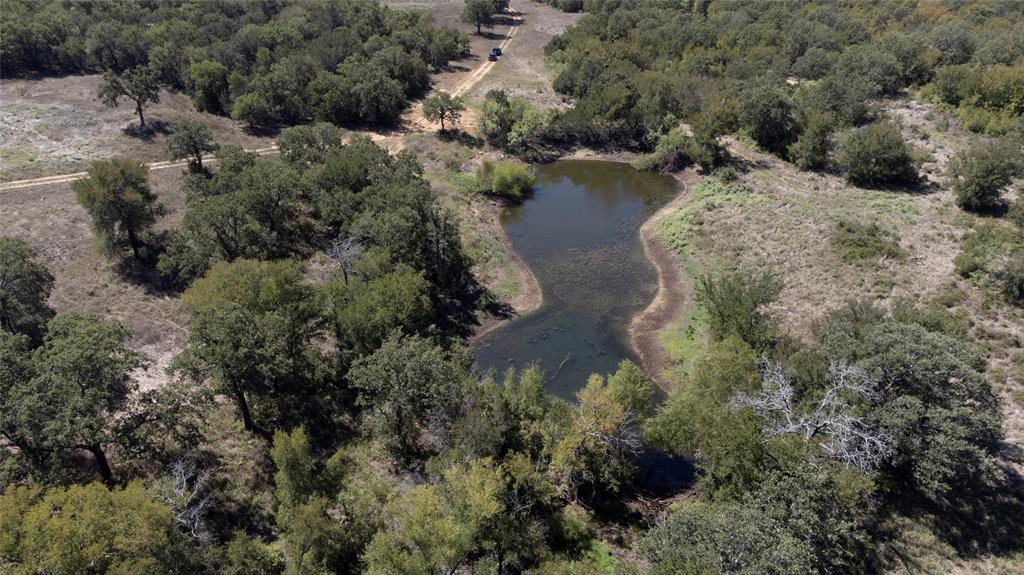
left=630, top=168, right=698, bottom=392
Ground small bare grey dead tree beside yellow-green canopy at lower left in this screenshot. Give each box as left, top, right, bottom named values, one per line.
left=154, top=457, right=213, bottom=544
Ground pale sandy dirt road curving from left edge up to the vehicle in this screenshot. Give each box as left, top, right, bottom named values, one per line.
left=0, top=7, right=520, bottom=192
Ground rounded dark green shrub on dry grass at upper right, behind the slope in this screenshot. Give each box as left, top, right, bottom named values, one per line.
left=839, top=122, right=918, bottom=187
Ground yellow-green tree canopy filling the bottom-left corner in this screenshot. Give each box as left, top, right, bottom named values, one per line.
left=0, top=481, right=196, bottom=575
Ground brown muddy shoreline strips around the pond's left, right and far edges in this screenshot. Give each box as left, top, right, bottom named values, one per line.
left=468, top=149, right=697, bottom=392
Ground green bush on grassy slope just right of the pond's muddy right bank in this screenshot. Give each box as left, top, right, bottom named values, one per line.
left=696, top=270, right=782, bottom=350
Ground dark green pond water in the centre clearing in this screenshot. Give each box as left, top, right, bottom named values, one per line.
left=476, top=160, right=677, bottom=398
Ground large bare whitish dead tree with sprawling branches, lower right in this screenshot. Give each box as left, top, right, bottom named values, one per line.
left=731, top=361, right=894, bottom=473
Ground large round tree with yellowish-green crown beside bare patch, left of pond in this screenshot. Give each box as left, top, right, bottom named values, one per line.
left=174, top=259, right=326, bottom=431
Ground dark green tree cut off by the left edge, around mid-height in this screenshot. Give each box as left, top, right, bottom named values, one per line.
left=0, top=236, right=53, bottom=343
